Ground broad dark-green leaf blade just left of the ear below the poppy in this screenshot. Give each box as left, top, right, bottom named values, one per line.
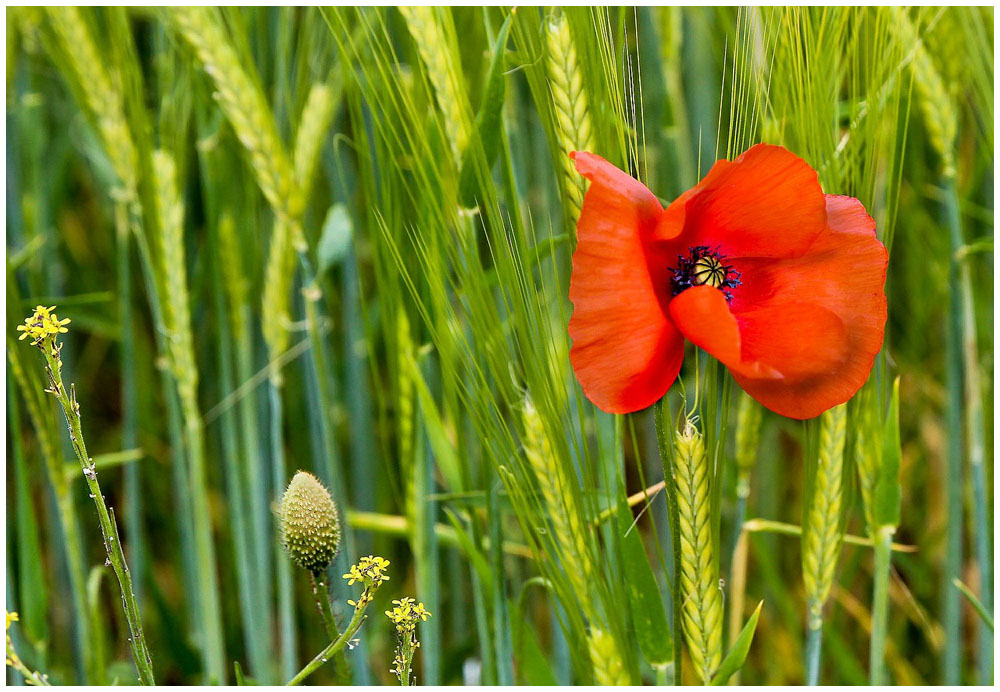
left=618, top=494, right=674, bottom=666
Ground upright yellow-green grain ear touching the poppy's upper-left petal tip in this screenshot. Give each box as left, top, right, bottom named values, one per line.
left=546, top=15, right=594, bottom=227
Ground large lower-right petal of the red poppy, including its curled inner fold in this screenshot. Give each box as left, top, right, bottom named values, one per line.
left=671, top=195, right=888, bottom=418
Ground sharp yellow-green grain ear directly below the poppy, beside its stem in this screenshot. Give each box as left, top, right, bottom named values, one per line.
left=674, top=421, right=723, bottom=685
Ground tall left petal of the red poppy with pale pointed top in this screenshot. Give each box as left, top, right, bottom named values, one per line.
left=569, top=152, right=684, bottom=413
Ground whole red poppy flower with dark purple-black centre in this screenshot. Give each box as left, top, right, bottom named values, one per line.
left=569, top=144, right=888, bottom=418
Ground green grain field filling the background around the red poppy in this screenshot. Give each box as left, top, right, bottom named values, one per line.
left=5, top=7, right=994, bottom=685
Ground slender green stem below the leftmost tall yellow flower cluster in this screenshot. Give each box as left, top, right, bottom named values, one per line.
left=42, top=340, right=156, bottom=685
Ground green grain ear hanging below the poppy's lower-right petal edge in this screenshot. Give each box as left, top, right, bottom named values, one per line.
left=802, top=404, right=847, bottom=630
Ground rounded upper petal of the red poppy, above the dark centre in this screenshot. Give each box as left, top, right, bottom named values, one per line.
left=656, top=144, right=826, bottom=257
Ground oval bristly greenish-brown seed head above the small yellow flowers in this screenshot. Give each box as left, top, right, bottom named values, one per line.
left=278, top=471, right=340, bottom=574
